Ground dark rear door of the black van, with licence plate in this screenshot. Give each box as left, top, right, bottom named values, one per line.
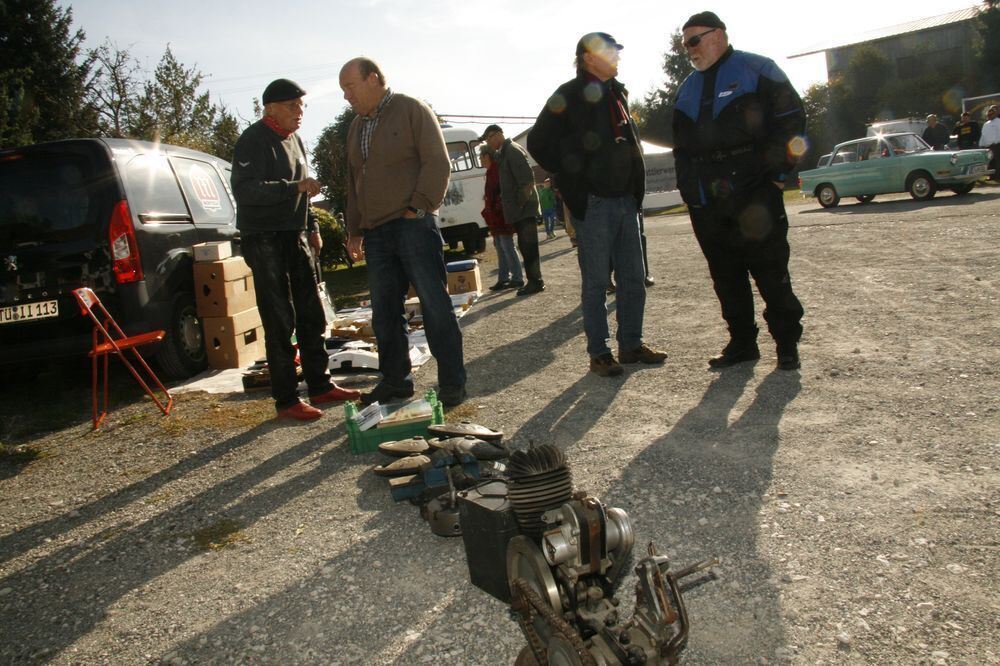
left=0, top=141, right=117, bottom=361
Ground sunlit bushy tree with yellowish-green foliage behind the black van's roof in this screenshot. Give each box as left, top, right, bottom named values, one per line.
left=130, top=45, right=216, bottom=150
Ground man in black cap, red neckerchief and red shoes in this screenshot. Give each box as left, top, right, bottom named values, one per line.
left=231, top=79, right=361, bottom=421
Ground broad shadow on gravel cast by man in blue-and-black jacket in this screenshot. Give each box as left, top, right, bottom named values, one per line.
left=608, top=366, right=801, bottom=664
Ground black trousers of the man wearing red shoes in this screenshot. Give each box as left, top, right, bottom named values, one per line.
left=242, top=231, right=333, bottom=409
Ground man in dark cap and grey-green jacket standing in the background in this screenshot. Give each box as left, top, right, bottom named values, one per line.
left=479, top=125, right=545, bottom=296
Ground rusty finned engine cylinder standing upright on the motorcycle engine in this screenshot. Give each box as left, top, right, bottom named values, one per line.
left=507, top=444, right=573, bottom=541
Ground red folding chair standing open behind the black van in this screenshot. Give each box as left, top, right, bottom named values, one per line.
left=73, top=287, right=174, bottom=430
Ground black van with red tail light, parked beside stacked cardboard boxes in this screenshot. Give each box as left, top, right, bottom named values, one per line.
left=0, top=139, right=237, bottom=378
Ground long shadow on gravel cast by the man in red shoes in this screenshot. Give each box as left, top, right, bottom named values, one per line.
left=0, top=424, right=351, bottom=663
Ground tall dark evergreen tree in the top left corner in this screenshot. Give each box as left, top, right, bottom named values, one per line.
left=0, top=0, right=97, bottom=148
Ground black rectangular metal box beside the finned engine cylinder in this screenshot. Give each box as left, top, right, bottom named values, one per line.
left=458, top=479, right=517, bottom=604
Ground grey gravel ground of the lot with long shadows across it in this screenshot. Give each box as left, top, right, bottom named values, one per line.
left=0, top=188, right=1000, bottom=664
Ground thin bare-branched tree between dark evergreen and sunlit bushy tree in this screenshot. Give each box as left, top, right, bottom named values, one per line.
left=89, top=39, right=143, bottom=138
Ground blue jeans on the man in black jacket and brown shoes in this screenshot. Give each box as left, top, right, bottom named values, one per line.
left=573, top=194, right=646, bottom=358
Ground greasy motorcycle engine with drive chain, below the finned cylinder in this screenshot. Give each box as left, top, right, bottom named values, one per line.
left=507, top=493, right=715, bottom=665
